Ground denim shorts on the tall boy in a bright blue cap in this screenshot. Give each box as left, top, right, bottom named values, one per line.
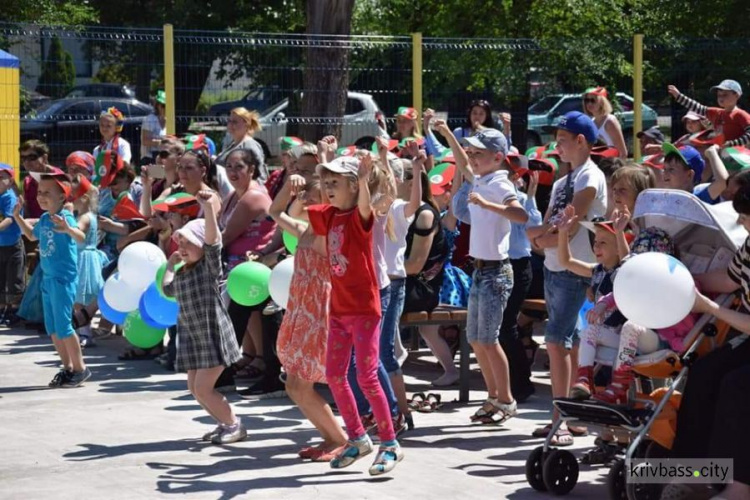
left=544, top=267, right=591, bottom=349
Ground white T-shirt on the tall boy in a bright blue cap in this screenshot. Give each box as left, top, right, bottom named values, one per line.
left=544, top=159, right=607, bottom=272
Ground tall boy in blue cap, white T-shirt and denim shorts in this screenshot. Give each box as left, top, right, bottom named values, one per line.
left=528, top=111, right=607, bottom=446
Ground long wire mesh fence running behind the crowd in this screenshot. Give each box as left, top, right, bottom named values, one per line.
left=0, top=24, right=750, bottom=166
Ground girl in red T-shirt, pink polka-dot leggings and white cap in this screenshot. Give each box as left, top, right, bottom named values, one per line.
left=308, top=155, right=404, bottom=475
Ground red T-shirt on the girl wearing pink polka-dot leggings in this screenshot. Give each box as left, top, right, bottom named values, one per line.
left=307, top=205, right=381, bottom=316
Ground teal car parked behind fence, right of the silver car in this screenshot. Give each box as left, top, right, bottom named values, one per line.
left=528, top=92, right=657, bottom=151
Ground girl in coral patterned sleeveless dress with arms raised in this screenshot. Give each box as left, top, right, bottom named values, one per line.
left=269, top=175, right=346, bottom=462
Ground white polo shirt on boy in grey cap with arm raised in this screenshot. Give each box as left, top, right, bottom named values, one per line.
left=469, top=170, right=518, bottom=260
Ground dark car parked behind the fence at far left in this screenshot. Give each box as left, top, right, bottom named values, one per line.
left=21, top=98, right=153, bottom=164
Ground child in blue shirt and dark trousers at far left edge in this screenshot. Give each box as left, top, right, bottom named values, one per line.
left=0, top=163, right=26, bottom=327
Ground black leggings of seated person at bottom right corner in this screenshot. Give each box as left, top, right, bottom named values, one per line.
left=672, top=335, right=750, bottom=484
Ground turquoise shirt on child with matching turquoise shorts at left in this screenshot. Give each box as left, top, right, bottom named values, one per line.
left=33, top=210, right=78, bottom=282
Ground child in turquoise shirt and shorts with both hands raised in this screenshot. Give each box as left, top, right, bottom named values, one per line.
left=13, top=169, right=91, bottom=388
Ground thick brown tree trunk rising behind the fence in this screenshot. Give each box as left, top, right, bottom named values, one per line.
left=299, top=0, right=354, bottom=142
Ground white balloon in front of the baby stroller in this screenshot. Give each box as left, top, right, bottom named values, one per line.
left=614, top=252, right=695, bottom=328
